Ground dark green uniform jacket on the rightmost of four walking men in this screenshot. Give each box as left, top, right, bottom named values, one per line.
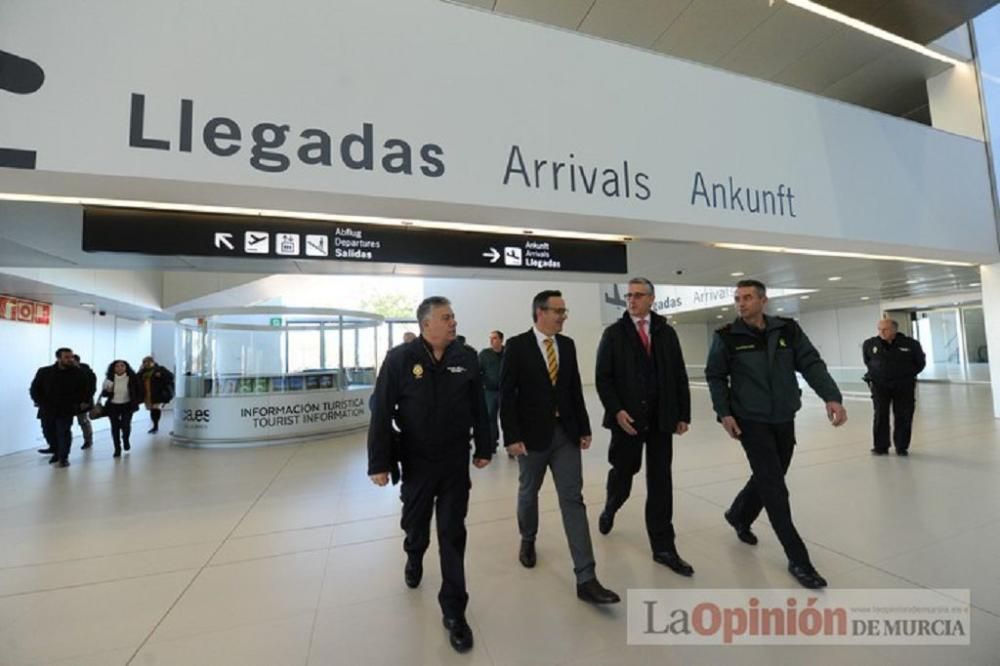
left=705, top=317, right=843, bottom=423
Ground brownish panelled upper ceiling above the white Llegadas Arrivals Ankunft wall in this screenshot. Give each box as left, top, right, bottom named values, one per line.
left=447, top=0, right=998, bottom=124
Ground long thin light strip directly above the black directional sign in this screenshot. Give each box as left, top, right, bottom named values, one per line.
left=0, top=192, right=626, bottom=242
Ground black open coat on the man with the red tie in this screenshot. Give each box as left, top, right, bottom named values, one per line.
left=597, top=311, right=691, bottom=432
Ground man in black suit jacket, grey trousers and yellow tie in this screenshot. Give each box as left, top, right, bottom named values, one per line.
left=500, top=290, right=620, bottom=604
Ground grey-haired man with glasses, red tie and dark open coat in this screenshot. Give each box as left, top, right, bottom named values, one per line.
left=597, top=277, right=694, bottom=576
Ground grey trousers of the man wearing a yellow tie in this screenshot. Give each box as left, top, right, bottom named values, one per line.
left=517, top=424, right=597, bottom=584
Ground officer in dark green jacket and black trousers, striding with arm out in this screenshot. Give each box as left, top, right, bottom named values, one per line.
left=705, top=280, right=847, bottom=588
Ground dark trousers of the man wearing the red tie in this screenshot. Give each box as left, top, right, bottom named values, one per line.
left=604, top=428, right=674, bottom=553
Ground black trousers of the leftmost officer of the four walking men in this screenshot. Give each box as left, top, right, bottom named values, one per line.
left=400, top=460, right=472, bottom=618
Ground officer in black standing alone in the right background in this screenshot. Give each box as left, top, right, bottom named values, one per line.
left=861, top=319, right=927, bottom=456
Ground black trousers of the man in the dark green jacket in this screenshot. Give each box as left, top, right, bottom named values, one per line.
left=729, top=420, right=809, bottom=564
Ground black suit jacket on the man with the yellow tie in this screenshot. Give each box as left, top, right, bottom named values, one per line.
left=500, top=328, right=590, bottom=451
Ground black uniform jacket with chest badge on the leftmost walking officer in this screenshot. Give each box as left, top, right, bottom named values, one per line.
left=368, top=337, right=495, bottom=475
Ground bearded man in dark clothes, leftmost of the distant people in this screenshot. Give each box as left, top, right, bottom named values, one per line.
left=30, top=347, right=93, bottom=467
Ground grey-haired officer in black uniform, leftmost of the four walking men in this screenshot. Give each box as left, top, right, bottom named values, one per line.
left=368, top=296, right=496, bottom=652
